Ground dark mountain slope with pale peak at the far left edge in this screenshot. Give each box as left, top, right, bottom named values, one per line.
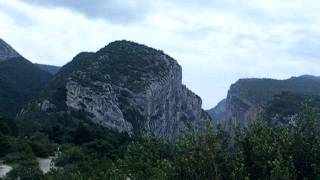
left=0, top=40, right=51, bottom=116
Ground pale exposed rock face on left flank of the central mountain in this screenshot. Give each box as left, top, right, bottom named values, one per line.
left=66, top=80, right=132, bottom=133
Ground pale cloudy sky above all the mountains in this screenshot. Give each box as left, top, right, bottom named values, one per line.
left=0, top=0, right=320, bottom=109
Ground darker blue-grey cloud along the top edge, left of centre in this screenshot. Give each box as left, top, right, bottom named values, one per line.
left=22, top=0, right=151, bottom=24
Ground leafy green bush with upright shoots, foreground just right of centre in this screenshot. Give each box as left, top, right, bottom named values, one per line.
left=173, top=123, right=233, bottom=179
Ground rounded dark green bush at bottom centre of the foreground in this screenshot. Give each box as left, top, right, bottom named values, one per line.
left=117, top=135, right=173, bottom=180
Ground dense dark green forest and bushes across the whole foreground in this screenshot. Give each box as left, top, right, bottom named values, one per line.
left=0, top=108, right=320, bottom=180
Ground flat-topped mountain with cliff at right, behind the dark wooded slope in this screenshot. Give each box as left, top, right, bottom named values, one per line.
left=212, top=75, right=320, bottom=128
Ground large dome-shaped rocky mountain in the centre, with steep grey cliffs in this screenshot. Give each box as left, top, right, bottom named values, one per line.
left=19, top=41, right=209, bottom=141
